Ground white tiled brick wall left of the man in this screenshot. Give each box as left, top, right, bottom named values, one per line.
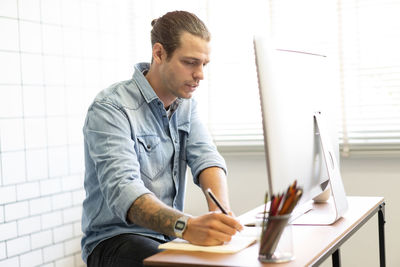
left=0, top=0, right=132, bottom=267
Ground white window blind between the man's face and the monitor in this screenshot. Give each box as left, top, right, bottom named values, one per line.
left=208, top=0, right=268, bottom=149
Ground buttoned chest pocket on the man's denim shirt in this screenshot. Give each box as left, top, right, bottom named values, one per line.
left=137, top=135, right=166, bottom=180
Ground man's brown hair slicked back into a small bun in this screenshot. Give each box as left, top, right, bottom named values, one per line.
left=151, top=11, right=211, bottom=59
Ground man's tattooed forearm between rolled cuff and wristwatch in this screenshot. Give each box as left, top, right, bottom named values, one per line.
left=128, top=194, right=181, bottom=236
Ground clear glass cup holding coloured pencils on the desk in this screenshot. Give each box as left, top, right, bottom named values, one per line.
left=258, top=214, right=294, bottom=263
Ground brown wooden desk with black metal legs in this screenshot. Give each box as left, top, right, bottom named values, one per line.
left=144, top=197, right=385, bottom=267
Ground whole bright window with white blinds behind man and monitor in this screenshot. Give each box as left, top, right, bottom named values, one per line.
left=128, top=0, right=400, bottom=154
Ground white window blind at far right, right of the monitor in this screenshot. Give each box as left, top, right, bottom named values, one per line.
left=338, top=0, right=400, bottom=154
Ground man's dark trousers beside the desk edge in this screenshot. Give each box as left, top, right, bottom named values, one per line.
left=87, top=234, right=164, bottom=267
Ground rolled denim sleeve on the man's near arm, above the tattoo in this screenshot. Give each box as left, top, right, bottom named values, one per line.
left=83, top=102, right=151, bottom=224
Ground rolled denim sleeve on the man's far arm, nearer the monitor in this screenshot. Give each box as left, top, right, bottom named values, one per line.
left=186, top=100, right=227, bottom=185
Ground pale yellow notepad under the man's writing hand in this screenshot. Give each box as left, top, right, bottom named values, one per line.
left=158, top=227, right=258, bottom=253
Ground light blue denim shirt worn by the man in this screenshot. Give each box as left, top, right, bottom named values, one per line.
left=82, top=63, right=226, bottom=262
